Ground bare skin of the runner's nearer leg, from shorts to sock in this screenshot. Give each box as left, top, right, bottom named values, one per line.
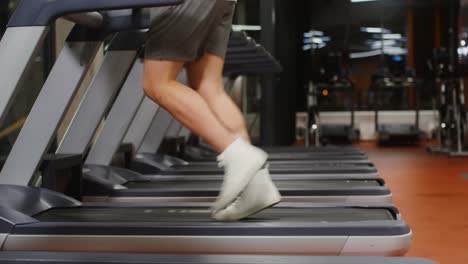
left=144, top=60, right=236, bottom=153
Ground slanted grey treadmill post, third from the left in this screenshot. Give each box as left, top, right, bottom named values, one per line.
left=56, top=32, right=143, bottom=155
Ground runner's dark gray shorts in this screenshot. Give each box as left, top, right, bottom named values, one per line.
left=145, top=0, right=236, bottom=62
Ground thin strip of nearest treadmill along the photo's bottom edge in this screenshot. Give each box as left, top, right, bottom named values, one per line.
left=0, top=252, right=436, bottom=264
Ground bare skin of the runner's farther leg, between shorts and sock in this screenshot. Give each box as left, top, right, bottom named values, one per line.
left=187, top=53, right=250, bottom=141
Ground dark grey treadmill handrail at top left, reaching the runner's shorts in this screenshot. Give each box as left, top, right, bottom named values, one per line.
left=8, top=0, right=184, bottom=27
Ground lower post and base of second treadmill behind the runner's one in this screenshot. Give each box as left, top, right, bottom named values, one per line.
left=128, top=112, right=376, bottom=175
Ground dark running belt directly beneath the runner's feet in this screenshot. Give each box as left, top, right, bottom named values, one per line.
left=34, top=207, right=395, bottom=223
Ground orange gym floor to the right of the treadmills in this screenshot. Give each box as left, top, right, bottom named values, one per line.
left=360, top=143, right=468, bottom=264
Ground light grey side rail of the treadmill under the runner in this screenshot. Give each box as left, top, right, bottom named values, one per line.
left=4, top=235, right=407, bottom=256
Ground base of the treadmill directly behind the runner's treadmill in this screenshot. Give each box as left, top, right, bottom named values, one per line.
left=82, top=165, right=392, bottom=204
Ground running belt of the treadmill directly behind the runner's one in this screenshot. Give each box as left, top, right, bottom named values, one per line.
left=125, top=180, right=381, bottom=191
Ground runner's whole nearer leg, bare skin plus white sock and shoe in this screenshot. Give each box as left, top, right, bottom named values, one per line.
left=144, top=60, right=267, bottom=211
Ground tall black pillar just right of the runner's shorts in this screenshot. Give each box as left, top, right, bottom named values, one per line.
left=260, top=0, right=309, bottom=145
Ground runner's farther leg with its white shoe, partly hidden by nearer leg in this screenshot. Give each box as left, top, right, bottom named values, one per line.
left=187, top=54, right=281, bottom=221
